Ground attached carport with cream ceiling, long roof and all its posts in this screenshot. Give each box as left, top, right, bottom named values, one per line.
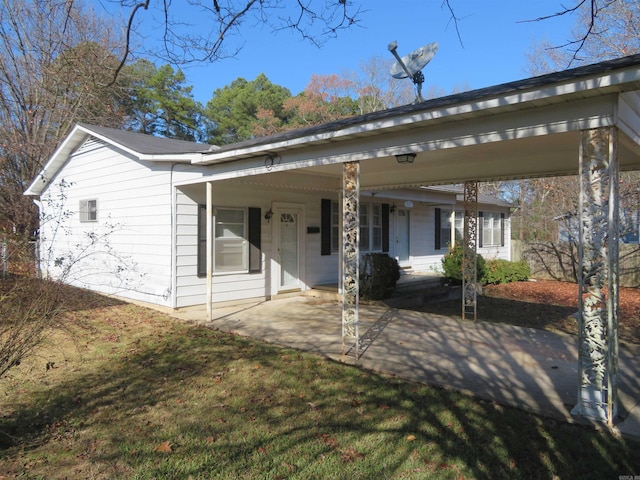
left=188, top=55, right=640, bottom=424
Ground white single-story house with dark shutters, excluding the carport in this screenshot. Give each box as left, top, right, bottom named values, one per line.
left=28, top=123, right=510, bottom=308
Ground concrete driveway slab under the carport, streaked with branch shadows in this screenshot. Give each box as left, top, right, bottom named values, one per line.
left=166, top=296, right=640, bottom=440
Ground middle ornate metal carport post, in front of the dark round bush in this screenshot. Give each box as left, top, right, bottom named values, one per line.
left=342, top=162, right=360, bottom=360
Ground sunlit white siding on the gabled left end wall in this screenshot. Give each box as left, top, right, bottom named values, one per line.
left=40, top=140, right=202, bottom=306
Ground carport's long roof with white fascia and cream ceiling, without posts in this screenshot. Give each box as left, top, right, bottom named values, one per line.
left=194, top=55, right=640, bottom=188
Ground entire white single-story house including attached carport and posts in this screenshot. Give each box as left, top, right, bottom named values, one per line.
left=21, top=51, right=640, bottom=425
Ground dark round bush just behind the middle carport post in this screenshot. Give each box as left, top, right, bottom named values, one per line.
left=360, top=253, right=400, bottom=300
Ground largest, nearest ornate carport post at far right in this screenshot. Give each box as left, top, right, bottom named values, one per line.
left=571, top=127, right=620, bottom=425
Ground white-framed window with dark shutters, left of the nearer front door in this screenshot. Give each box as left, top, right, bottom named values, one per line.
left=214, top=208, right=249, bottom=273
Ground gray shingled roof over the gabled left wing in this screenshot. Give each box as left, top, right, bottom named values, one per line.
left=79, top=123, right=218, bottom=155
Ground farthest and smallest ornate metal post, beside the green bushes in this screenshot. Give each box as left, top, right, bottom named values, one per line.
left=462, top=180, right=478, bottom=320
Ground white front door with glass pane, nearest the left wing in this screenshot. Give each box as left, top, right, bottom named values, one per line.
left=278, top=210, right=300, bottom=290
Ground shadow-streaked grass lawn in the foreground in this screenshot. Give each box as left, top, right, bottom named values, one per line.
left=0, top=304, right=640, bottom=480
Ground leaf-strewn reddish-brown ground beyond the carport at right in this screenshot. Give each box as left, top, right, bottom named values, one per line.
left=420, top=280, right=640, bottom=344
